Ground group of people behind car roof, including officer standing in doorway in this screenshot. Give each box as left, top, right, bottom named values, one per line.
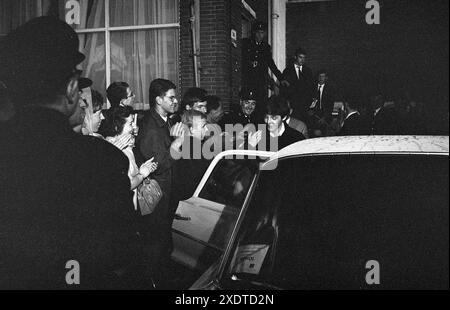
left=242, top=21, right=430, bottom=138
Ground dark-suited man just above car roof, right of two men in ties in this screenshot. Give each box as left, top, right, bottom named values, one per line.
left=339, top=98, right=370, bottom=136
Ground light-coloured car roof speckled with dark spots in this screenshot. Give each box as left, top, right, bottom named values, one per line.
left=262, top=136, right=449, bottom=168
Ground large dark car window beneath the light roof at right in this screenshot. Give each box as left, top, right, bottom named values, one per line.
left=225, top=155, right=449, bottom=289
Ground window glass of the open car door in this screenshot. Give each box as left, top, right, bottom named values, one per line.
left=199, top=159, right=258, bottom=209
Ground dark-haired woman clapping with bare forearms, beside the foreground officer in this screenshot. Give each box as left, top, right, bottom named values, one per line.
left=102, top=106, right=158, bottom=210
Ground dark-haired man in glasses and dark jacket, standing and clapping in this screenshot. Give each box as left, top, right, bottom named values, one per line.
left=137, top=79, right=184, bottom=288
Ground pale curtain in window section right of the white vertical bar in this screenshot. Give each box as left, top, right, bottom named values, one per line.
left=110, top=0, right=178, bottom=108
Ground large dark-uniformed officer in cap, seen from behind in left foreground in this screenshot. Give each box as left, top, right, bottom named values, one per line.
left=0, top=17, right=137, bottom=289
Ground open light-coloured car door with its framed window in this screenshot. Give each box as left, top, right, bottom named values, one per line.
left=172, top=151, right=268, bottom=272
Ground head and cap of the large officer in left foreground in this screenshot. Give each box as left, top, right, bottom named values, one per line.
left=0, top=16, right=85, bottom=100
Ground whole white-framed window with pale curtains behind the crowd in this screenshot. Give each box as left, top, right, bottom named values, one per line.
left=59, top=0, right=179, bottom=109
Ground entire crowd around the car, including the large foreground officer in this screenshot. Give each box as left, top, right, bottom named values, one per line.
left=0, top=17, right=436, bottom=288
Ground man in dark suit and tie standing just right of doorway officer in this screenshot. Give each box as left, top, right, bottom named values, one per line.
left=281, top=48, right=314, bottom=121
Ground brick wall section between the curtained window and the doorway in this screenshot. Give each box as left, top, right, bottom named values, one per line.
left=180, top=0, right=267, bottom=109
